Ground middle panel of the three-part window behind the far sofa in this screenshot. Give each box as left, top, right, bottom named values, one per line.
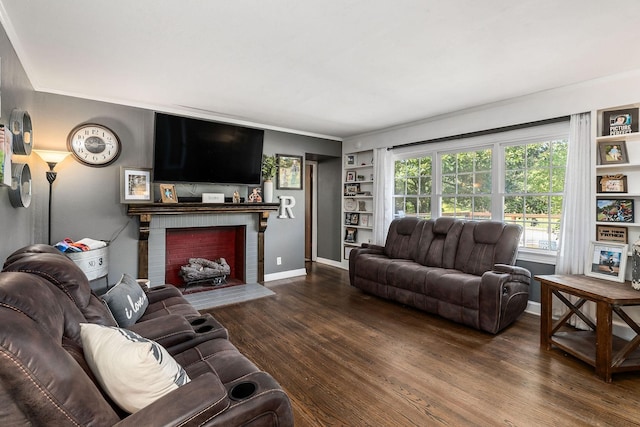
left=440, top=148, right=492, bottom=220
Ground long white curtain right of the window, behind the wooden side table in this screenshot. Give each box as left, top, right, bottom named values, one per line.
left=554, top=113, right=595, bottom=327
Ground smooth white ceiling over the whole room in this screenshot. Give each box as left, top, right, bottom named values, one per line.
left=0, top=0, right=640, bottom=138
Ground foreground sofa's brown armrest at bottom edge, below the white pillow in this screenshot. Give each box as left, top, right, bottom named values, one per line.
left=116, top=372, right=230, bottom=427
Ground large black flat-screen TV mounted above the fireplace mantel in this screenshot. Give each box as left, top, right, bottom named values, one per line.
left=153, top=113, right=264, bottom=185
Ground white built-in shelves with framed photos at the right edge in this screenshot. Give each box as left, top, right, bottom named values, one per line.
left=593, top=104, right=640, bottom=258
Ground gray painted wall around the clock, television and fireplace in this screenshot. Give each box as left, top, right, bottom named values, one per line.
left=0, top=14, right=342, bottom=282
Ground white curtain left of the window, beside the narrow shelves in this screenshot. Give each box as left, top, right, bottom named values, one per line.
left=373, top=148, right=393, bottom=245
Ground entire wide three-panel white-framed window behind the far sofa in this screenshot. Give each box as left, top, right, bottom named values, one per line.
left=393, top=121, right=569, bottom=258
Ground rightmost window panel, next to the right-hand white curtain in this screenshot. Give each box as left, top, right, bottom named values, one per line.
left=504, top=139, right=568, bottom=251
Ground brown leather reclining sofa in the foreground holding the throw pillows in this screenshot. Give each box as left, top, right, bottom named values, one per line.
left=0, top=245, right=293, bottom=427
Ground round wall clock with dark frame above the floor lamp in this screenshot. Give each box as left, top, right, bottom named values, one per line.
left=67, top=123, right=122, bottom=167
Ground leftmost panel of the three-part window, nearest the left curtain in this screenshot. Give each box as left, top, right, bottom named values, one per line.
left=393, top=156, right=432, bottom=219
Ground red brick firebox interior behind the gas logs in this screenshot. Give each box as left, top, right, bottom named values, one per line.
left=165, top=225, right=246, bottom=286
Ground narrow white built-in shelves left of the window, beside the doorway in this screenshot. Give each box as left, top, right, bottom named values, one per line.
left=341, top=150, right=376, bottom=264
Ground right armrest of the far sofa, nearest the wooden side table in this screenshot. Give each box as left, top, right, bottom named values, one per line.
left=479, top=264, right=531, bottom=334
